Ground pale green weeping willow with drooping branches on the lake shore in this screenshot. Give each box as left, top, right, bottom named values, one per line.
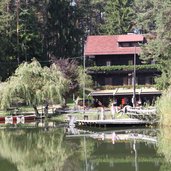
left=0, top=59, right=69, bottom=115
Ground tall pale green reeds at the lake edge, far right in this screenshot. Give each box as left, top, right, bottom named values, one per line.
left=156, top=88, right=171, bottom=127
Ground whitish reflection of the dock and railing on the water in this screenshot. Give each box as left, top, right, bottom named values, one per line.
left=67, top=127, right=157, bottom=144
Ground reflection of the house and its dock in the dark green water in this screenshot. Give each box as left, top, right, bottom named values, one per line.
left=66, top=127, right=161, bottom=171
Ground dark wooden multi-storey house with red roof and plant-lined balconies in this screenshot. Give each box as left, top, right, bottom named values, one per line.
left=85, top=34, right=161, bottom=105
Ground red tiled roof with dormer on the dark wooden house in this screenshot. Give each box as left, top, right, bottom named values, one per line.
left=84, top=35, right=144, bottom=56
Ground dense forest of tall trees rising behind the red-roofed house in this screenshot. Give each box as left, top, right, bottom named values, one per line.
left=0, top=0, right=171, bottom=88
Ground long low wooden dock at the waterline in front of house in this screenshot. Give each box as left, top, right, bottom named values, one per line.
left=69, top=118, right=151, bottom=126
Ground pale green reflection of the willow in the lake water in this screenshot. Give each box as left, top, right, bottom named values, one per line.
left=0, top=129, right=72, bottom=171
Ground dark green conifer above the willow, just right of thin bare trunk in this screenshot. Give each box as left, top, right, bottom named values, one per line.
left=18, top=5, right=42, bottom=61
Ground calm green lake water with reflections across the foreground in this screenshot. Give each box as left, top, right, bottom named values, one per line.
left=0, top=122, right=171, bottom=171
